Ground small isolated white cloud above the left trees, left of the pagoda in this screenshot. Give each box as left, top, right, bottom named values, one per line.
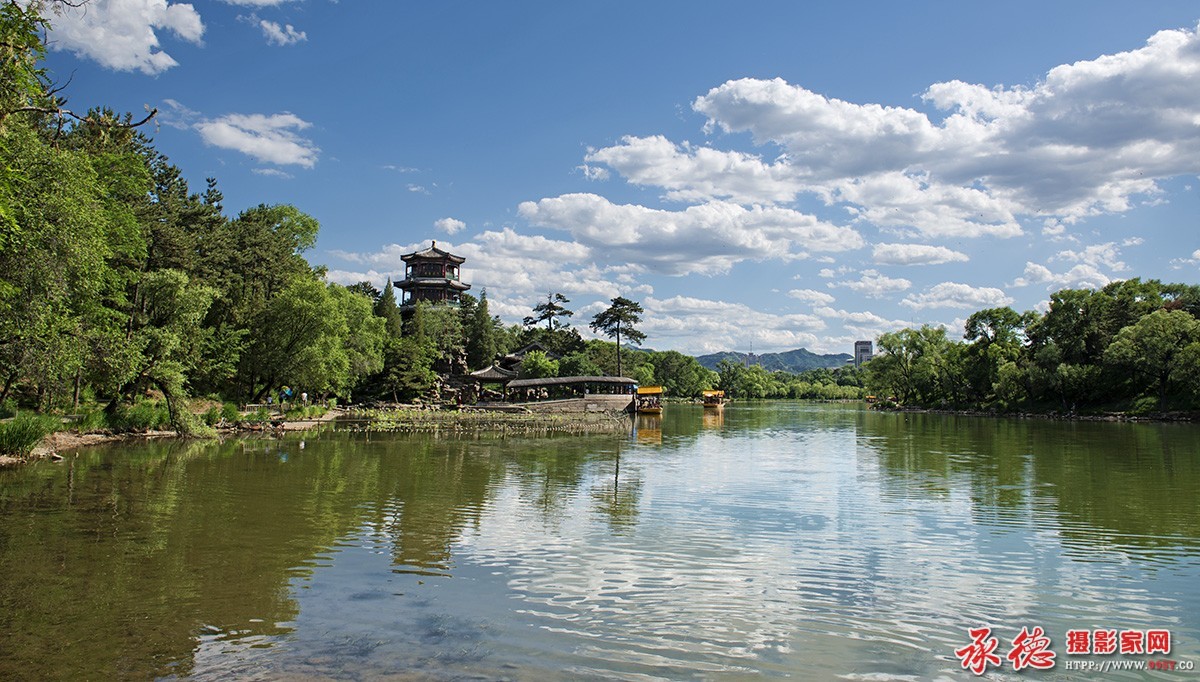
left=196, top=113, right=319, bottom=168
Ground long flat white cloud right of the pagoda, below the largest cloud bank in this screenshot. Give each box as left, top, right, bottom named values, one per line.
left=518, top=193, right=865, bottom=275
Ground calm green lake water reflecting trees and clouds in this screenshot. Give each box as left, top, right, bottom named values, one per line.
left=0, top=402, right=1200, bottom=681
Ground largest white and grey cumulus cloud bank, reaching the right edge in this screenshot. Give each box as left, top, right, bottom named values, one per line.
left=576, top=22, right=1200, bottom=238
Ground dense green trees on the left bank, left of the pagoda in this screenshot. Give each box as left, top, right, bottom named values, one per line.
left=0, top=0, right=386, bottom=429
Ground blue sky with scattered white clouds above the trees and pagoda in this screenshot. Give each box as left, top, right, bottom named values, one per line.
left=32, top=0, right=1200, bottom=354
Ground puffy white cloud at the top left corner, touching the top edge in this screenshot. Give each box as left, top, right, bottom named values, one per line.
left=42, top=0, right=204, bottom=74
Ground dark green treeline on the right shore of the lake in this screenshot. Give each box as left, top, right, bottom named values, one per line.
left=864, top=279, right=1200, bottom=414
